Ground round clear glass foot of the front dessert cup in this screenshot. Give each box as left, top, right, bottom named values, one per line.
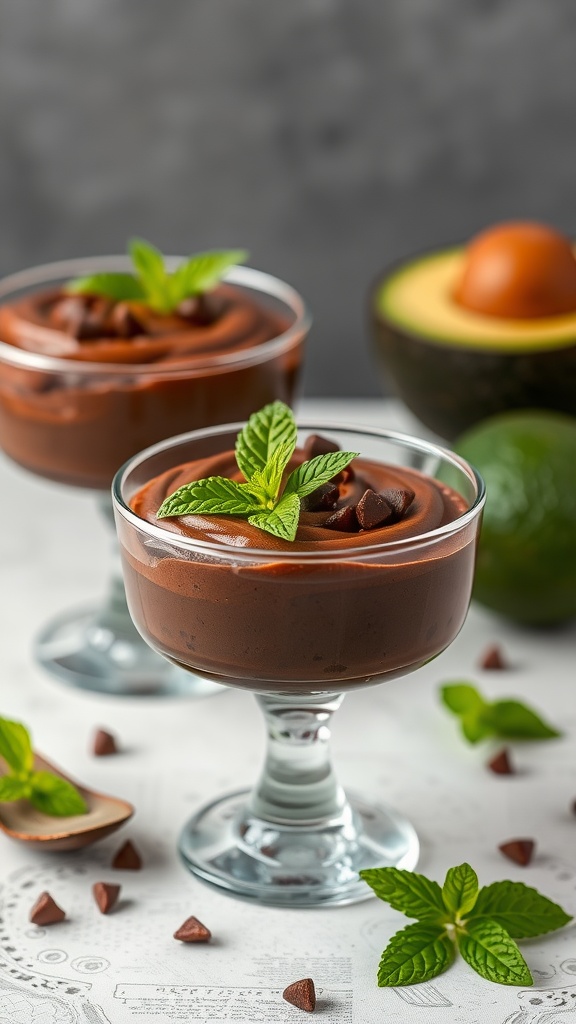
left=179, top=790, right=419, bottom=907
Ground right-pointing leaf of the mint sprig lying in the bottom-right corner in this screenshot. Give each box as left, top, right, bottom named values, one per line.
left=469, top=882, right=572, bottom=939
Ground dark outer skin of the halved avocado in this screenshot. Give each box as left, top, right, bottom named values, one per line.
left=372, top=313, right=576, bottom=441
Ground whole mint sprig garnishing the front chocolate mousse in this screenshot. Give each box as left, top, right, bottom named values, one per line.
left=157, top=401, right=359, bottom=541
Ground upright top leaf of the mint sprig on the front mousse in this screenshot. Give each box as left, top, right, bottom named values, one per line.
left=236, top=401, right=297, bottom=480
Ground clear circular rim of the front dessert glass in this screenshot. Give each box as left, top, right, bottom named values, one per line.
left=112, top=419, right=486, bottom=562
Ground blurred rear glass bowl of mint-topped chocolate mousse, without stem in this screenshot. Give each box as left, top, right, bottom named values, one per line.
left=0, top=243, right=307, bottom=488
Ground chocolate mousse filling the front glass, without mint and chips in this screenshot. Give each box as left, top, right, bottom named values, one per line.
left=120, top=453, right=476, bottom=692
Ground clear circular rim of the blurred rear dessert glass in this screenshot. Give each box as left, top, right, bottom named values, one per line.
left=0, top=255, right=312, bottom=377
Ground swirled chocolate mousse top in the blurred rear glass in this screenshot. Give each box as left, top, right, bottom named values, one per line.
left=0, top=285, right=288, bottom=365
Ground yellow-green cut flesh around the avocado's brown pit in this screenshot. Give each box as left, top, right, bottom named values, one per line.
left=375, top=248, right=576, bottom=352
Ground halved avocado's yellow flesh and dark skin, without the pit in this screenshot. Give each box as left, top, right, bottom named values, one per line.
left=371, top=248, right=576, bottom=440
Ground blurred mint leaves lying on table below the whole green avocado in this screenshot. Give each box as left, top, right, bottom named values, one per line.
left=441, top=683, right=562, bottom=743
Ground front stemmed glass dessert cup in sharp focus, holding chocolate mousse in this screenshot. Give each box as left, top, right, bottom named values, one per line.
left=113, top=424, right=484, bottom=907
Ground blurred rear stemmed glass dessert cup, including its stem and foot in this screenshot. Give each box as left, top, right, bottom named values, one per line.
left=0, top=256, right=310, bottom=696
